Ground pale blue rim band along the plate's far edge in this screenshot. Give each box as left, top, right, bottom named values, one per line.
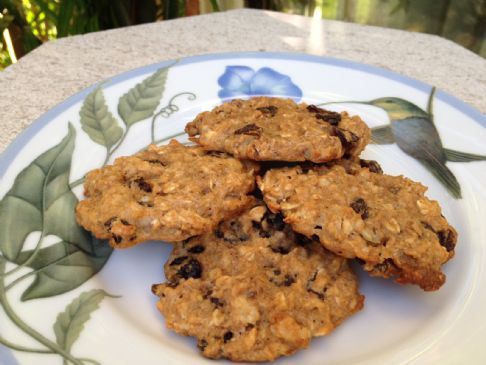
left=0, top=51, right=486, bottom=179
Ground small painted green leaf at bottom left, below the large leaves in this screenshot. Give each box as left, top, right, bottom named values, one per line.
left=54, top=289, right=109, bottom=351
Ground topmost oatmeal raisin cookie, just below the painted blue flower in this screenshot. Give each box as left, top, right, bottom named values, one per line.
left=186, top=97, right=370, bottom=163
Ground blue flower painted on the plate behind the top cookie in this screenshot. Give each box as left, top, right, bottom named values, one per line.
left=218, top=66, right=302, bottom=101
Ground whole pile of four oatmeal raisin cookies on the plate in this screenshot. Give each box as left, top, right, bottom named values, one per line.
left=77, top=97, right=457, bottom=361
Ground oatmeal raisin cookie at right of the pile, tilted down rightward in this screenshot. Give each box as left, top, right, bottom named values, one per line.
left=258, top=161, right=457, bottom=291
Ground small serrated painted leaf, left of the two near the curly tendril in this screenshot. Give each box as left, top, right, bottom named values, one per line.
left=79, top=88, right=123, bottom=149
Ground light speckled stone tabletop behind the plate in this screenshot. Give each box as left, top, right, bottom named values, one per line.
left=0, top=9, right=486, bottom=151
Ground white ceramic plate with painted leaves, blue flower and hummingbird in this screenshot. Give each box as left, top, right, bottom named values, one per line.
left=0, top=53, right=486, bottom=365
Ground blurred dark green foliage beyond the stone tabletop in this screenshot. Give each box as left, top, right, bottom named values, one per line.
left=0, top=0, right=486, bottom=69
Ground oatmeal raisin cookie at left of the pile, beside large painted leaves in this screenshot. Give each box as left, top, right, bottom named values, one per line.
left=76, top=140, right=256, bottom=248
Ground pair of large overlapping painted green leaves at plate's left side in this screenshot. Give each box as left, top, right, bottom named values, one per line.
left=0, top=125, right=111, bottom=300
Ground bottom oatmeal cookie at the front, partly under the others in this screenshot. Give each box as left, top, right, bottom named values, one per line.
left=152, top=200, right=364, bottom=361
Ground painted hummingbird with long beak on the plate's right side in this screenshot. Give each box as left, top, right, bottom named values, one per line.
left=321, top=88, right=486, bottom=199
